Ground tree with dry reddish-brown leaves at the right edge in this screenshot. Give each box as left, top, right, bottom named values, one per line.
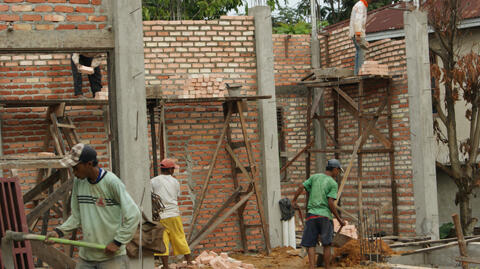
left=423, top=0, right=480, bottom=235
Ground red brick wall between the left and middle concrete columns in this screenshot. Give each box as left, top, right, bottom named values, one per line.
left=144, top=16, right=263, bottom=251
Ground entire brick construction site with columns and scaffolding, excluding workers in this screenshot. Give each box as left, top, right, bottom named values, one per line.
left=0, top=0, right=480, bottom=269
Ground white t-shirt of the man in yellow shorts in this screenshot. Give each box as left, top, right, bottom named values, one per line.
left=151, top=175, right=180, bottom=219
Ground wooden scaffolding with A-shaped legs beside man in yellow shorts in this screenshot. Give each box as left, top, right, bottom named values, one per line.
left=147, top=96, right=271, bottom=253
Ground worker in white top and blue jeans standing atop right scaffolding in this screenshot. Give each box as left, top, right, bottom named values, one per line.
left=349, top=0, right=373, bottom=76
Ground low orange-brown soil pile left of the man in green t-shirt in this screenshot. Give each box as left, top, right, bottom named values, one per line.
left=229, top=247, right=308, bottom=269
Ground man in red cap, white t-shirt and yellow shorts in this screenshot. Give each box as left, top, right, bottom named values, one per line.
left=152, top=159, right=192, bottom=269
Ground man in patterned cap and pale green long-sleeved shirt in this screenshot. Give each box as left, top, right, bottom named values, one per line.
left=45, top=141, right=140, bottom=269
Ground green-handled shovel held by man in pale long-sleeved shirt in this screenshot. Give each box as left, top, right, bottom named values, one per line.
left=1, top=230, right=106, bottom=268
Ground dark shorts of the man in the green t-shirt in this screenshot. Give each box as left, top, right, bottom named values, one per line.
left=300, top=214, right=333, bottom=248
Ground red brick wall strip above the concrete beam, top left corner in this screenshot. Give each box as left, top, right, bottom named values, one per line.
left=0, top=0, right=109, bottom=31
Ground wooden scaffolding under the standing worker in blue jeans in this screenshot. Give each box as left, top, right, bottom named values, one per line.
left=281, top=71, right=399, bottom=235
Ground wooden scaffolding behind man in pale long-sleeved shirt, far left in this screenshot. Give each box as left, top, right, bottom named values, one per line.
left=0, top=99, right=109, bottom=268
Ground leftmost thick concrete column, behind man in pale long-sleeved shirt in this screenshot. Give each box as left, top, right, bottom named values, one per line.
left=110, top=0, right=154, bottom=268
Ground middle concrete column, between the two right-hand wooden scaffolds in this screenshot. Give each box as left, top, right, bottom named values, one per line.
left=248, top=6, right=282, bottom=247
